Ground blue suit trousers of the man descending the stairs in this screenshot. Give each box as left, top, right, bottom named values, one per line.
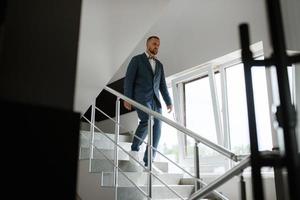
left=131, top=99, right=161, bottom=166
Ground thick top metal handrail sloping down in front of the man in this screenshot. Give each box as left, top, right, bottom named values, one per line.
left=104, top=86, right=238, bottom=162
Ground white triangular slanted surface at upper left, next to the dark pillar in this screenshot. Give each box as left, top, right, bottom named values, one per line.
left=74, top=0, right=169, bottom=112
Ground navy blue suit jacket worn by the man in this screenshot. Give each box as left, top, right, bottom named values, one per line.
left=124, top=53, right=172, bottom=107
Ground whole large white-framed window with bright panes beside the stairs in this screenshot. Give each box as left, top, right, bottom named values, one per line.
left=168, top=43, right=296, bottom=173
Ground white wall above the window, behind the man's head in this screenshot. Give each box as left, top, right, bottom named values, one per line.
left=111, top=0, right=270, bottom=82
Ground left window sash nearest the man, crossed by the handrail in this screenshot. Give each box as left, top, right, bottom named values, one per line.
left=179, top=67, right=225, bottom=173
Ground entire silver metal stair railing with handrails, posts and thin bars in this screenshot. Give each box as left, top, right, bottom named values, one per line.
left=82, top=87, right=250, bottom=200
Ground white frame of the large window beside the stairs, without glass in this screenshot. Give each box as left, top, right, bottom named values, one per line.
left=168, top=42, right=299, bottom=173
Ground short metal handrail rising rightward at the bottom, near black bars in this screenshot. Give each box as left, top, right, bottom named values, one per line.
left=188, top=155, right=251, bottom=200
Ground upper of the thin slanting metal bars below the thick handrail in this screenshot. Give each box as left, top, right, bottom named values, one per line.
left=95, top=106, right=228, bottom=200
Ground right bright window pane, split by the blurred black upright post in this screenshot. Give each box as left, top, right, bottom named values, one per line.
left=226, top=64, right=272, bottom=154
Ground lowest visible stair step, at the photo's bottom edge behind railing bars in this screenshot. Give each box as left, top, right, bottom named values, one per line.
left=118, top=185, right=194, bottom=200
